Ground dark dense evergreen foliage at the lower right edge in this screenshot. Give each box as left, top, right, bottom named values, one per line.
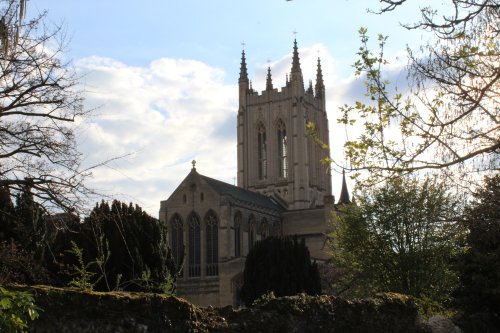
left=457, top=175, right=500, bottom=332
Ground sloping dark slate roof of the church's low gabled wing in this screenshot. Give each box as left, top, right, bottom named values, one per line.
left=200, top=175, right=285, bottom=212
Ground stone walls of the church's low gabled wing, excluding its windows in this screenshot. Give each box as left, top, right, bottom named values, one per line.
left=160, top=171, right=281, bottom=306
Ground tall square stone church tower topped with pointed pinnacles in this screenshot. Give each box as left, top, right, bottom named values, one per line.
left=237, top=41, right=331, bottom=210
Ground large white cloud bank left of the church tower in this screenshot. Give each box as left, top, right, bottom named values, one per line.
left=76, top=57, right=238, bottom=216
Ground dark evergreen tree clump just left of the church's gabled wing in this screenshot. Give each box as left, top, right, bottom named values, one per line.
left=65, top=200, right=178, bottom=292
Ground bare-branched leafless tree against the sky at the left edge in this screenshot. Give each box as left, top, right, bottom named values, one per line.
left=0, top=0, right=94, bottom=211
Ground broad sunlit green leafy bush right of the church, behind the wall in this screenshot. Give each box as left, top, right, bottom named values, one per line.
left=332, top=178, right=461, bottom=303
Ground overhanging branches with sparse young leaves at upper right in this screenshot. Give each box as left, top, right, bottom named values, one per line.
left=330, top=0, right=500, bottom=184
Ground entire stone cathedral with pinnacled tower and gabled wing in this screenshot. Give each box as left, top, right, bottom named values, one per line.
left=159, top=40, right=349, bottom=307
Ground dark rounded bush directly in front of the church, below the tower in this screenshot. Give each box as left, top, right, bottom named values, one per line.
left=241, top=237, right=321, bottom=305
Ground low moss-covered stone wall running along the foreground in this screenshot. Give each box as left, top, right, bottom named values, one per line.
left=10, top=286, right=429, bottom=333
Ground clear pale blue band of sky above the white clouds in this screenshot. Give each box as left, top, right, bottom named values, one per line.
left=33, top=0, right=425, bottom=78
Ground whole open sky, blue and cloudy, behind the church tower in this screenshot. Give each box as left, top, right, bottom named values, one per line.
left=28, top=0, right=428, bottom=216
